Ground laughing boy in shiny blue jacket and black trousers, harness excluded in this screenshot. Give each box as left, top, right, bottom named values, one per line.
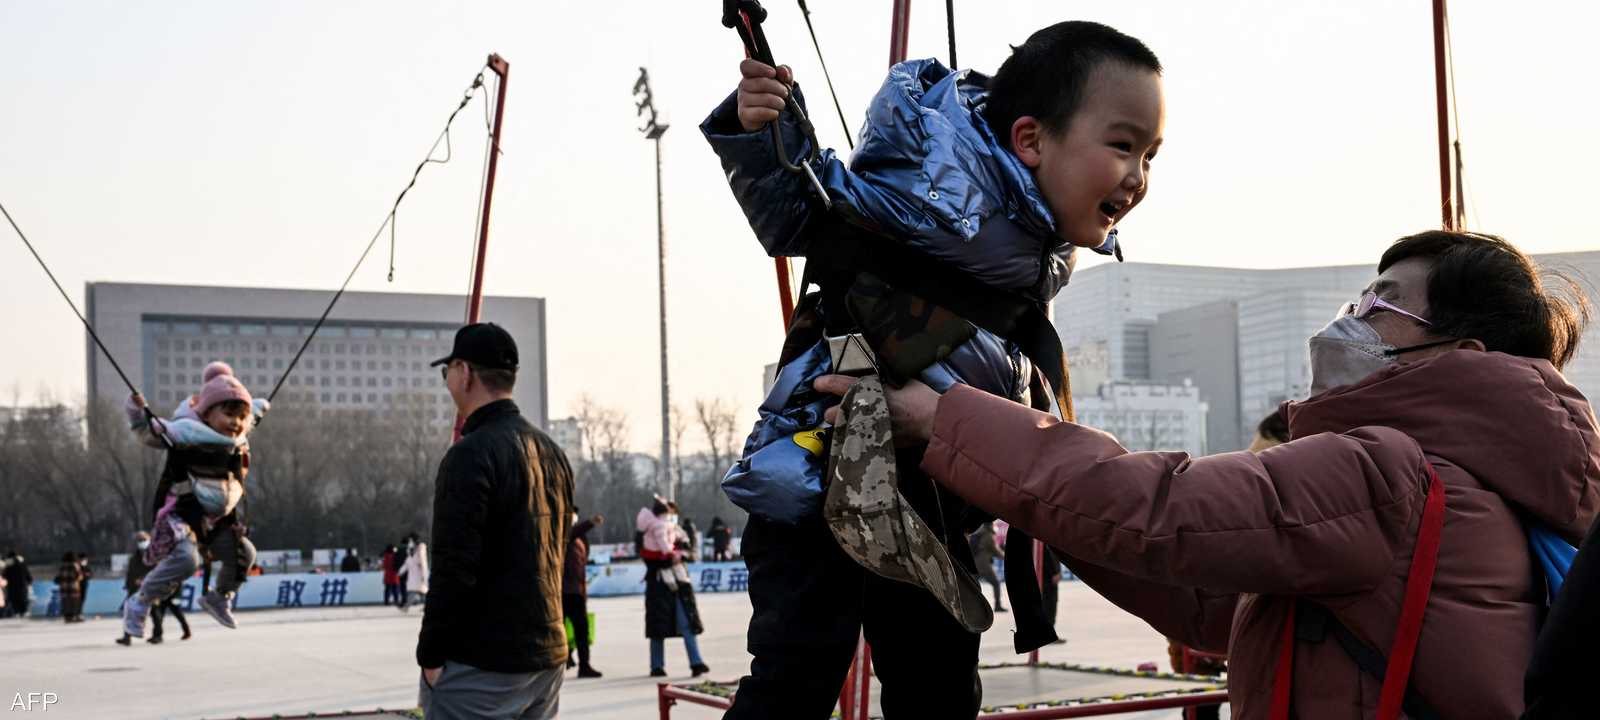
left=701, top=22, right=1165, bottom=720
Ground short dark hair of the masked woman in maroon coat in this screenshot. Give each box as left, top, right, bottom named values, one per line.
left=1378, top=230, right=1589, bottom=368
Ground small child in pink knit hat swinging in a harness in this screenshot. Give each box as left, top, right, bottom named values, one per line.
left=123, top=363, right=267, bottom=637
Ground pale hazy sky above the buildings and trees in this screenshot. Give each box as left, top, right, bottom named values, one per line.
left=0, top=0, right=1600, bottom=450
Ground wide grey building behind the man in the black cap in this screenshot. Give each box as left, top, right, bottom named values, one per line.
left=86, top=283, right=549, bottom=427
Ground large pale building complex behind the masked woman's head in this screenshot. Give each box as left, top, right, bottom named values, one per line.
left=1054, top=253, right=1600, bottom=453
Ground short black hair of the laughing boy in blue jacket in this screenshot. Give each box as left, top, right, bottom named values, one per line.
left=982, top=21, right=1162, bottom=149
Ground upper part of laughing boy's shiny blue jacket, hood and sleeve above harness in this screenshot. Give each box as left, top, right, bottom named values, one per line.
left=701, top=59, right=1117, bottom=302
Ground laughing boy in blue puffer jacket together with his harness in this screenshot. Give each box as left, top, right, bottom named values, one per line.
left=701, top=18, right=1165, bottom=720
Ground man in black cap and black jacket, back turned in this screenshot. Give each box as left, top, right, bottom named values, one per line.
left=416, top=323, right=573, bottom=720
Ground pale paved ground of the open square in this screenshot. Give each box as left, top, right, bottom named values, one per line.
left=0, top=582, right=1222, bottom=720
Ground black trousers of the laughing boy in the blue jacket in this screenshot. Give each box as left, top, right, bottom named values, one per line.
left=723, top=502, right=982, bottom=720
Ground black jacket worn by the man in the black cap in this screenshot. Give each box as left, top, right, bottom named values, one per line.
left=416, top=400, right=573, bottom=672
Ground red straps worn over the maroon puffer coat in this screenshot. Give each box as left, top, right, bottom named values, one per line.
left=1269, top=464, right=1445, bottom=720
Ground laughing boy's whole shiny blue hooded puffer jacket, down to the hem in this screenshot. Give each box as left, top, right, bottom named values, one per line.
left=701, top=59, right=1115, bottom=523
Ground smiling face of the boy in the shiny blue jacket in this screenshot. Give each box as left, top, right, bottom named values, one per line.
left=1011, top=62, right=1166, bottom=248
